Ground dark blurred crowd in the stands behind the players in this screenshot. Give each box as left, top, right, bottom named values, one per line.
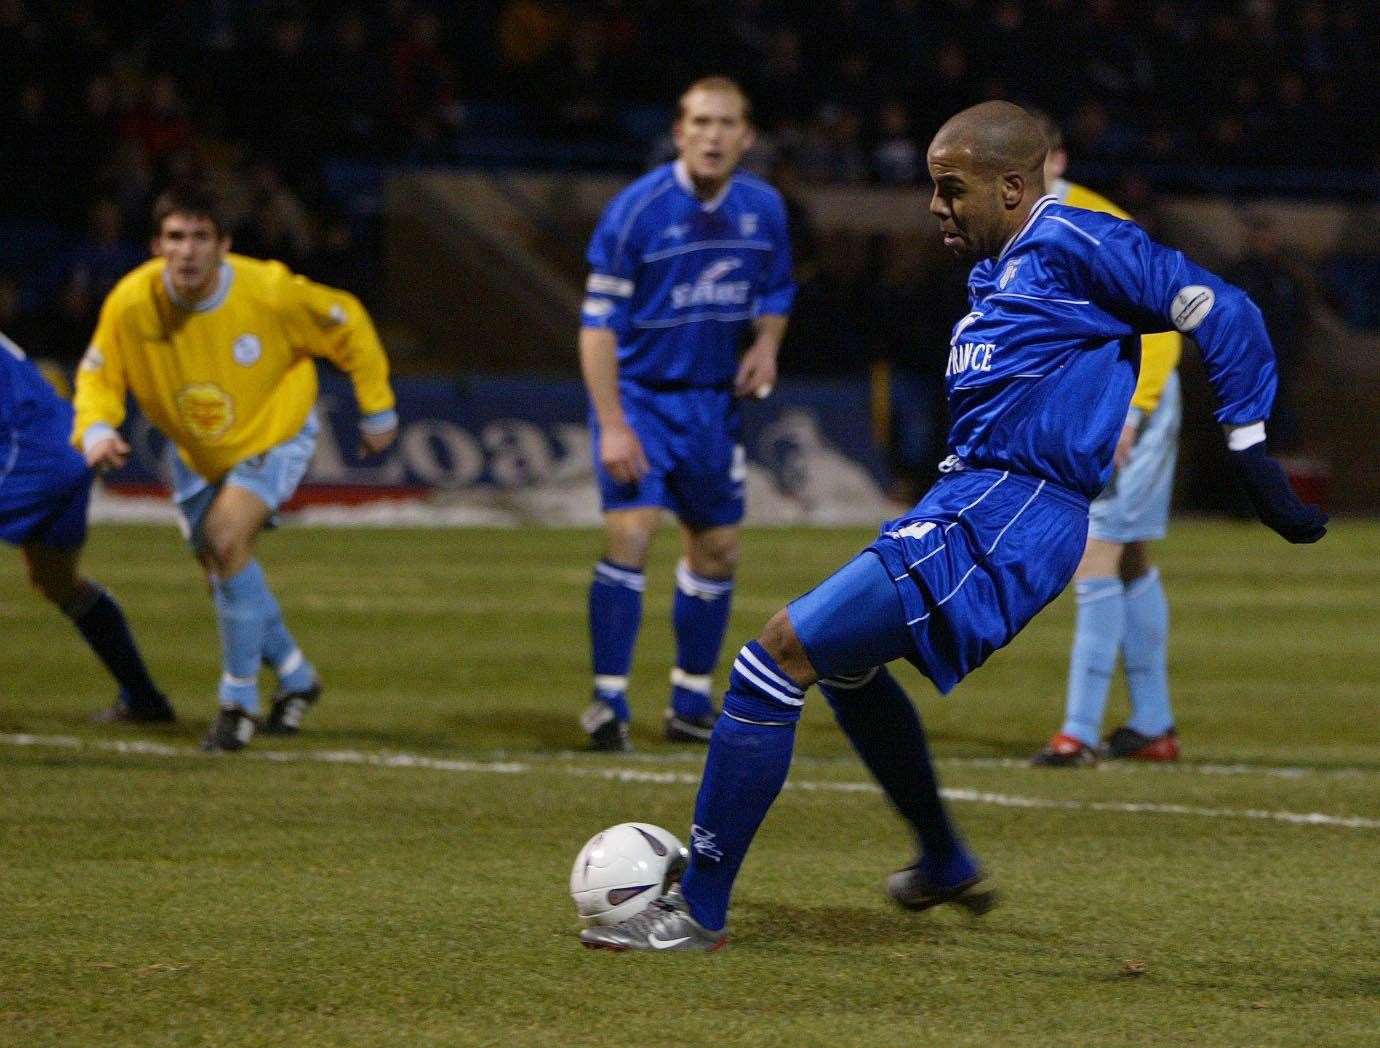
left=0, top=0, right=1380, bottom=370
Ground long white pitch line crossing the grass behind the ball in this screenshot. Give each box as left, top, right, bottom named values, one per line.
left=0, top=732, right=1380, bottom=830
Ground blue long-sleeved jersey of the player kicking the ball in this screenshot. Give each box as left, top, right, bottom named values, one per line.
left=945, top=196, right=1277, bottom=498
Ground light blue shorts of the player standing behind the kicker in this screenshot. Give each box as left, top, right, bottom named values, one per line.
left=1087, top=371, right=1183, bottom=543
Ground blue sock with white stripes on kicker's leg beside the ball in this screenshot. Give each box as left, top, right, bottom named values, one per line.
left=682, top=641, right=805, bottom=931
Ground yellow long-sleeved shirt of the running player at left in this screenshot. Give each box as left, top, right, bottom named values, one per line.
left=72, top=254, right=393, bottom=483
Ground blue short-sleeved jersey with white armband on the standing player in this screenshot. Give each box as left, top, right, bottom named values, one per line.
left=581, top=162, right=795, bottom=387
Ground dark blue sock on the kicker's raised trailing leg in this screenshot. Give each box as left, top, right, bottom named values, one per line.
left=820, top=666, right=978, bottom=885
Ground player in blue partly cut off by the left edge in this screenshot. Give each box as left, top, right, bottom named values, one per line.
left=0, top=334, right=174, bottom=724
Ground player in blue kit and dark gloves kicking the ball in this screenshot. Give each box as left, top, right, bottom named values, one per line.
left=581, top=102, right=1326, bottom=950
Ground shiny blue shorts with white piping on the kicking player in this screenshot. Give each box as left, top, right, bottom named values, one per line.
left=787, top=469, right=1087, bottom=693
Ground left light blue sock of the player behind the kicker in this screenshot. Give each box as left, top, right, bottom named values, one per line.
left=1060, top=579, right=1126, bottom=746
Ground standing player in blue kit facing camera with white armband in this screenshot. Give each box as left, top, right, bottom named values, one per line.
left=580, top=77, right=795, bottom=751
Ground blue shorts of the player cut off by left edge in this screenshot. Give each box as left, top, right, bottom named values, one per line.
left=0, top=431, right=94, bottom=550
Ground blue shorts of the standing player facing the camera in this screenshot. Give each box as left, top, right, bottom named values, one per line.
left=589, top=382, right=748, bottom=529
